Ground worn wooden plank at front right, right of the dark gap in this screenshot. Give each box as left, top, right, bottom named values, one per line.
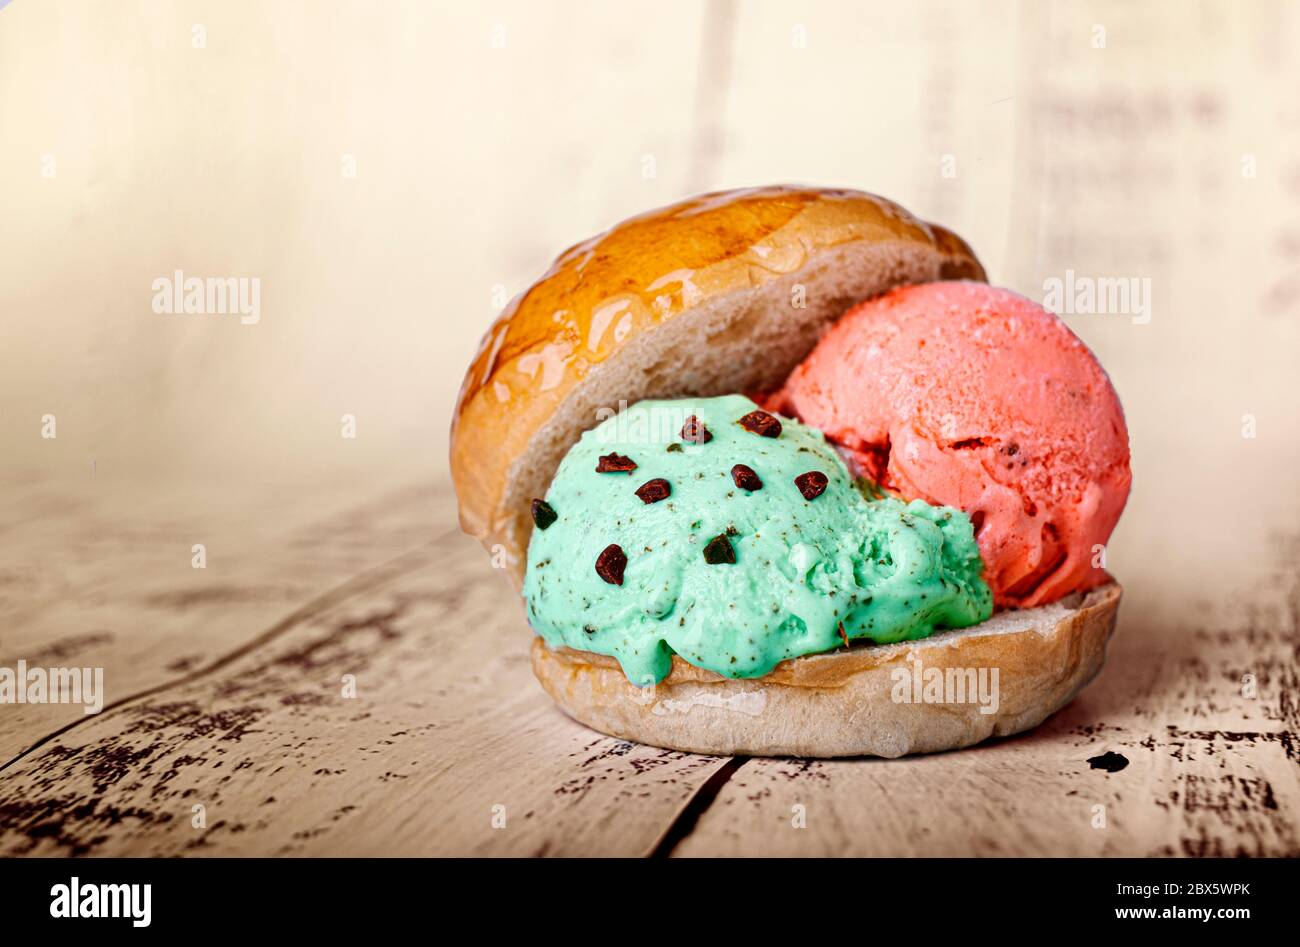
left=673, top=554, right=1300, bottom=856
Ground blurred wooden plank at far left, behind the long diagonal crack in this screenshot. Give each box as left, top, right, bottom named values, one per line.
left=0, top=476, right=441, bottom=764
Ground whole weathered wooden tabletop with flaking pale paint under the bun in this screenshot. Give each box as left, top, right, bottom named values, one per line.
left=0, top=479, right=1300, bottom=856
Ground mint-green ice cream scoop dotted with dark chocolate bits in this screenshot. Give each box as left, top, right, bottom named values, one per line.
left=524, top=395, right=993, bottom=686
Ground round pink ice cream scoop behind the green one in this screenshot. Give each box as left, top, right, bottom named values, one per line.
left=770, top=282, right=1132, bottom=607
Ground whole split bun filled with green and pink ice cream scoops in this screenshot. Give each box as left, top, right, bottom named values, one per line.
left=451, top=187, right=1130, bottom=757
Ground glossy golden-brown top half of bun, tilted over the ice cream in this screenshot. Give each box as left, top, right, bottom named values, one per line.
left=451, top=187, right=984, bottom=587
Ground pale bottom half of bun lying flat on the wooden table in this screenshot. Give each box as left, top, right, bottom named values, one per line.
left=533, top=581, right=1121, bottom=757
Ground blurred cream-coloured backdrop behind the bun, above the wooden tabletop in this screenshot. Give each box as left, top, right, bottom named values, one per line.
left=0, top=0, right=1300, bottom=609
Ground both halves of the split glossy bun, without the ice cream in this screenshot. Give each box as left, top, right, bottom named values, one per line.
left=451, top=187, right=1121, bottom=757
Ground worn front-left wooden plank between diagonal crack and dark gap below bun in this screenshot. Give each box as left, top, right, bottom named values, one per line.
left=0, top=507, right=722, bottom=855
